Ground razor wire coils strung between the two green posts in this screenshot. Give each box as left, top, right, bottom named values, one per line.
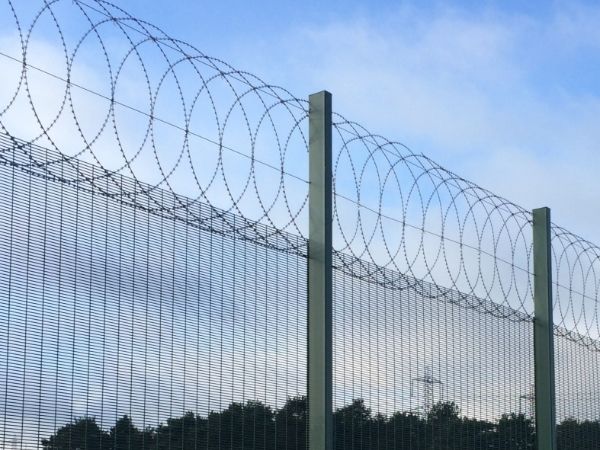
left=334, top=116, right=533, bottom=317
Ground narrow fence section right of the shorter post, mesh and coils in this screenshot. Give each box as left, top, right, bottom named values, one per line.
left=552, top=230, right=600, bottom=450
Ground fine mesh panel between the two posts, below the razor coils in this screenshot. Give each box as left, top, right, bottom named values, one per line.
left=334, top=258, right=534, bottom=449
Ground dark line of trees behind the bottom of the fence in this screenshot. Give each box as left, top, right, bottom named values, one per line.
left=41, top=396, right=600, bottom=450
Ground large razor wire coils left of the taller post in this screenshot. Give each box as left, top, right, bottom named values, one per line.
left=0, top=0, right=308, bottom=237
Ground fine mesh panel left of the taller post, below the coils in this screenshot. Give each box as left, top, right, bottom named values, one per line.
left=0, top=141, right=306, bottom=449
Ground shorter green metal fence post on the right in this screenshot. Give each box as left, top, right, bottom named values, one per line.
left=533, top=208, right=556, bottom=450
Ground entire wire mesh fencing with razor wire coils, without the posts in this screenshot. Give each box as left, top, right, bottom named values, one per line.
left=0, top=0, right=600, bottom=449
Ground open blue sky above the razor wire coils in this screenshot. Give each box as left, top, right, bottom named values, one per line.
left=110, top=0, right=600, bottom=242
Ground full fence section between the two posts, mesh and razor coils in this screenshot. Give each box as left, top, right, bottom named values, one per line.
left=333, top=116, right=535, bottom=449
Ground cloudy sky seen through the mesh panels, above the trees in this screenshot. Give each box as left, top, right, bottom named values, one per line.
left=0, top=149, right=540, bottom=442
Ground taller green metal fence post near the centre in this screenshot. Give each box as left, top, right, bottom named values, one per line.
left=308, top=91, right=333, bottom=450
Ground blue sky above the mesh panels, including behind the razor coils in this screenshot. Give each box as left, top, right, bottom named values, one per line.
left=0, top=0, right=600, bottom=336
